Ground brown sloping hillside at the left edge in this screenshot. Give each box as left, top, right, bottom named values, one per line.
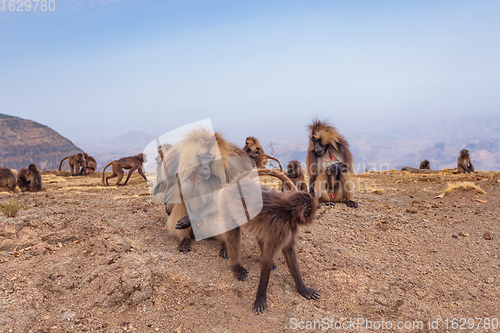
left=0, top=114, right=81, bottom=170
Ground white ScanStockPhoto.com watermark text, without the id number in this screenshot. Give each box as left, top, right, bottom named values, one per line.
left=289, top=318, right=425, bottom=332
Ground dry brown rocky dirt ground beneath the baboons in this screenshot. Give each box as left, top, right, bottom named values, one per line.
left=0, top=171, right=500, bottom=332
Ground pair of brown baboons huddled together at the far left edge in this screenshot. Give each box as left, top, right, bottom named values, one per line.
left=0, top=164, right=43, bottom=192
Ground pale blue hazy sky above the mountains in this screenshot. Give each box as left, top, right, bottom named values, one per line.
left=0, top=0, right=500, bottom=142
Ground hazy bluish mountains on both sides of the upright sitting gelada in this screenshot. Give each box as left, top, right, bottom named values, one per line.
left=268, top=113, right=500, bottom=172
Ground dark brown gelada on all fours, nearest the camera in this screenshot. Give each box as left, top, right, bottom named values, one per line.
left=176, top=174, right=320, bottom=314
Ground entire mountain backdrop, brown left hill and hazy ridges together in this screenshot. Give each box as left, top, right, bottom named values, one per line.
left=0, top=114, right=500, bottom=172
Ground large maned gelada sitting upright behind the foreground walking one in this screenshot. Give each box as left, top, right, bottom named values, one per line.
left=306, top=120, right=358, bottom=208
